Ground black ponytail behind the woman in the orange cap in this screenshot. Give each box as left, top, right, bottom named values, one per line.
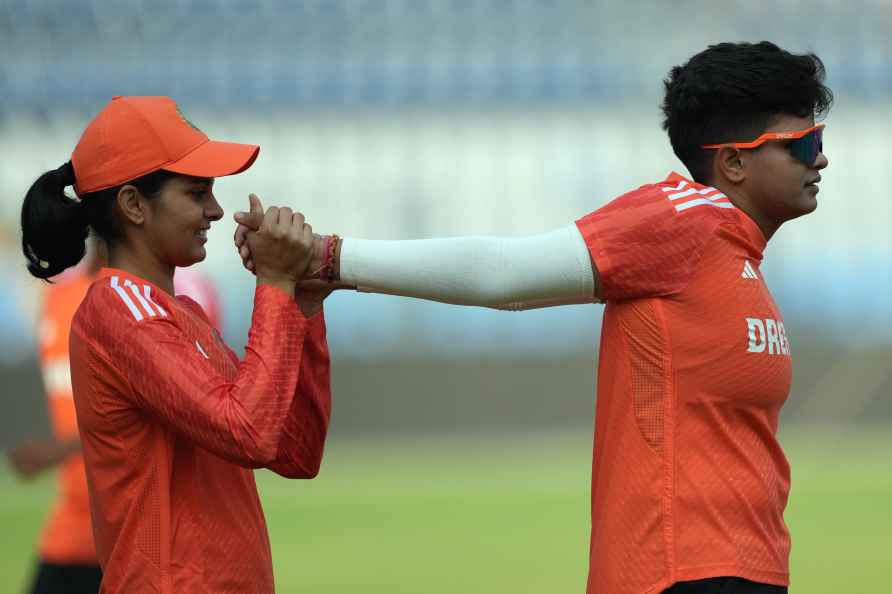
left=22, top=161, right=89, bottom=280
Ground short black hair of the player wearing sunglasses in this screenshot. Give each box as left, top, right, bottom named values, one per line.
left=662, top=41, right=833, bottom=183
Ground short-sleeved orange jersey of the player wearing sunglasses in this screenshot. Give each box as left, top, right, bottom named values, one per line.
left=577, top=174, right=792, bottom=594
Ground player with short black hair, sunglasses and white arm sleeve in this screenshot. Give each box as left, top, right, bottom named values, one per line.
left=235, top=42, right=833, bottom=594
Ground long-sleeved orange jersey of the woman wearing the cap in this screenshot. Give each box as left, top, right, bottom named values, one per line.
left=71, top=269, right=330, bottom=594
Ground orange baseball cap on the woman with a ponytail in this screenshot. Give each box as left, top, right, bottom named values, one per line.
left=71, top=97, right=260, bottom=195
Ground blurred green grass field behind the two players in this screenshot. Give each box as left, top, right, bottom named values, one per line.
left=0, top=427, right=892, bottom=594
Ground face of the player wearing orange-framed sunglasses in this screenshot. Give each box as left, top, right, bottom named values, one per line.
left=740, top=115, right=828, bottom=232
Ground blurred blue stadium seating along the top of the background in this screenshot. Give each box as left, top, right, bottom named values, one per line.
left=0, top=0, right=892, bottom=112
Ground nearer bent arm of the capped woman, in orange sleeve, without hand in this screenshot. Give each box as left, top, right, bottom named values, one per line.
left=117, top=286, right=306, bottom=467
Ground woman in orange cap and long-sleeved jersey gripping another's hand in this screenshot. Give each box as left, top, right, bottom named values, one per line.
left=22, top=97, right=330, bottom=594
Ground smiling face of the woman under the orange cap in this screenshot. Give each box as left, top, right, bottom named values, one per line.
left=145, top=175, right=223, bottom=267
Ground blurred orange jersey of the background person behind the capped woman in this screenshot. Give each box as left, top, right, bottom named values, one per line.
left=38, top=272, right=96, bottom=565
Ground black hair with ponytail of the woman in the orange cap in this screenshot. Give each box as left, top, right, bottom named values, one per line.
left=22, top=161, right=177, bottom=280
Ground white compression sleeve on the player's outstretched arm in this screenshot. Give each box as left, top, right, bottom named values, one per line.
left=340, top=224, right=596, bottom=309
